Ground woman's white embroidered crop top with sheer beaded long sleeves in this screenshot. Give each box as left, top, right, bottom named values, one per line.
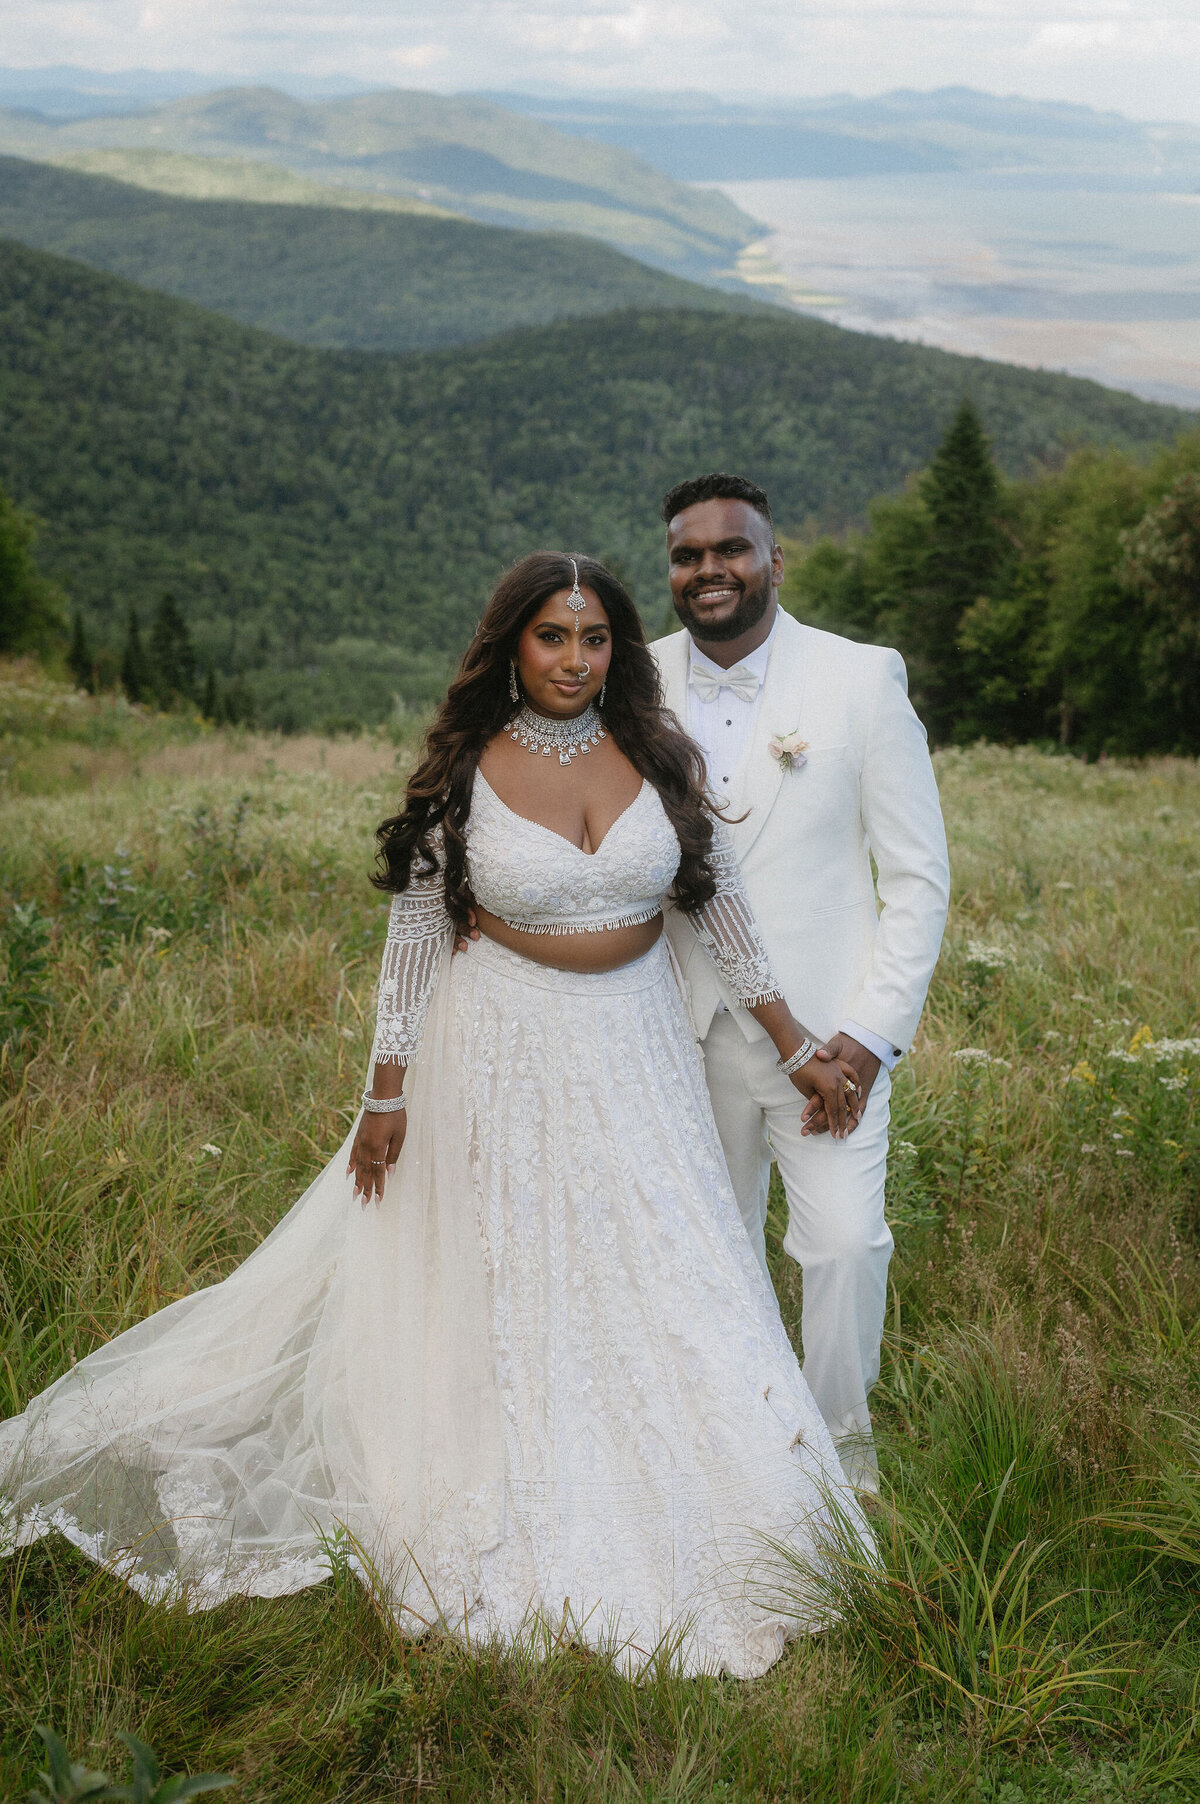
left=375, top=772, right=783, bottom=1064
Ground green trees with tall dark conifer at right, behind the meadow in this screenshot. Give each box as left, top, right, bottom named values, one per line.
left=785, top=400, right=1200, bottom=756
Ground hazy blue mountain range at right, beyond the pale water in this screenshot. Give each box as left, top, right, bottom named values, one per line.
left=487, top=88, right=1200, bottom=184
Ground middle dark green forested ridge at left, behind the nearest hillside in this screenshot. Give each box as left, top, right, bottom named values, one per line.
left=0, top=157, right=756, bottom=350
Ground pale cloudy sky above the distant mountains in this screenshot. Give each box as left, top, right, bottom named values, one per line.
left=0, top=0, right=1200, bottom=123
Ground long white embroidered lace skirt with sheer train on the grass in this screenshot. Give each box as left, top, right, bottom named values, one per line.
left=0, top=940, right=870, bottom=1676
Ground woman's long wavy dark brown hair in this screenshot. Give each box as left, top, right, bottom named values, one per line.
left=372, top=552, right=716, bottom=927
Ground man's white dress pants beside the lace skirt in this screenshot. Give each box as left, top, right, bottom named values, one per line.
left=704, top=1010, right=891, bottom=1490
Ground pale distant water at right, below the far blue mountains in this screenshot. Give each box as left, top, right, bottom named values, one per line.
left=720, top=171, right=1200, bottom=408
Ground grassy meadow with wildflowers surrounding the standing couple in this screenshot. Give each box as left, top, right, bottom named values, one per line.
left=0, top=669, right=1200, bottom=1804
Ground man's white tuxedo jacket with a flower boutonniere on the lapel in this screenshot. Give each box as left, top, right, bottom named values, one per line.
left=651, top=610, right=949, bottom=1052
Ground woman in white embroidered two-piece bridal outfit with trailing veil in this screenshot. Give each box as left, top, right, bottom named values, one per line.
left=0, top=552, right=868, bottom=1676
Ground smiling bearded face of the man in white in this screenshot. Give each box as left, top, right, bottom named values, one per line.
left=666, top=500, right=783, bottom=644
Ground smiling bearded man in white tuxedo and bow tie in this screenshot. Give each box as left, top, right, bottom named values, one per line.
left=651, top=474, right=949, bottom=1488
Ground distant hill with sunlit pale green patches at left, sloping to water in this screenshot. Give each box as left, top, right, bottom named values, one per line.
left=0, top=88, right=762, bottom=278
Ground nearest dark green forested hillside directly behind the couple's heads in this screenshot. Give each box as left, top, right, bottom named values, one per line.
left=0, top=242, right=1193, bottom=722
